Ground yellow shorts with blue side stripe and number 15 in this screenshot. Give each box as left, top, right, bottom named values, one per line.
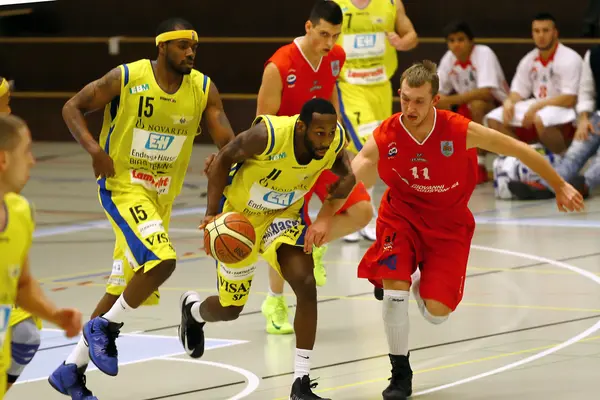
left=98, top=188, right=177, bottom=305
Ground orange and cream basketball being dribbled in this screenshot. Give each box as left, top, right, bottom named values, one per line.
left=204, top=212, right=256, bottom=264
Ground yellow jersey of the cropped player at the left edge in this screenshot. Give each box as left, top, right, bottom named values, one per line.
left=0, top=193, right=35, bottom=398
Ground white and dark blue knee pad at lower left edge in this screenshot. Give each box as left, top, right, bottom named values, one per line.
left=6, top=318, right=40, bottom=383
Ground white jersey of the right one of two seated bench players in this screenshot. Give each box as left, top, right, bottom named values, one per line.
left=510, top=43, right=582, bottom=100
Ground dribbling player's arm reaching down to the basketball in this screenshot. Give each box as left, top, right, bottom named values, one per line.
left=201, top=121, right=268, bottom=222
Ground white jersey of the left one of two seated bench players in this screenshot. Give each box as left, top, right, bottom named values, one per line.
left=438, top=44, right=508, bottom=103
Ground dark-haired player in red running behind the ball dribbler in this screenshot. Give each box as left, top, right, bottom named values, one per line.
left=256, top=1, right=373, bottom=334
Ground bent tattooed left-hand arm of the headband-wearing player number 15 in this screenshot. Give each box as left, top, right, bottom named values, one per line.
left=62, top=67, right=121, bottom=157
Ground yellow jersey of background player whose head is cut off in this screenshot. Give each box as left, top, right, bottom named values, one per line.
left=335, top=0, right=398, bottom=85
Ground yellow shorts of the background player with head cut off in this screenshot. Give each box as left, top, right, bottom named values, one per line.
left=337, top=81, right=392, bottom=154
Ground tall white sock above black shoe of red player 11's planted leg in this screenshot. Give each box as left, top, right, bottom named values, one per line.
left=382, top=290, right=409, bottom=356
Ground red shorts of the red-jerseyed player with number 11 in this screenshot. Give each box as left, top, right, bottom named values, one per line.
left=358, top=199, right=475, bottom=311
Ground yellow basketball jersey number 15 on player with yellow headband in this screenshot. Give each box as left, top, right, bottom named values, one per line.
left=99, top=60, right=210, bottom=204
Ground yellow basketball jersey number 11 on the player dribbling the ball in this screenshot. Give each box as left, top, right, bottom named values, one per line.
left=224, top=115, right=345, bottom=216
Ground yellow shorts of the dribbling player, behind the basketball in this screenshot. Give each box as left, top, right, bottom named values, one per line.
left=217, top=200, right=307, bottom=307
